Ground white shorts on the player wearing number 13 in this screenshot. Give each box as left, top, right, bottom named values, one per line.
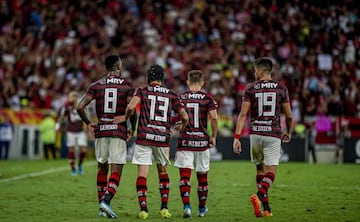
left=131, top=144, right=171, bottom=166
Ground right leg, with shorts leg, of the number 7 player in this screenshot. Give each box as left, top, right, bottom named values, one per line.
left=195, top=149, right=210, bottom=217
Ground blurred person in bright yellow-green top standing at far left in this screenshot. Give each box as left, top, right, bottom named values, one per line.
left=39, top=112, right=56, bottom=160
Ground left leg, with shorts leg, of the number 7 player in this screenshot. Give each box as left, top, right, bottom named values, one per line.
left=174, top=151, right=194, bottom=218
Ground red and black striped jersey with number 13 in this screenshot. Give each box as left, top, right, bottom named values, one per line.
left=134, top=85, right=184, bottom=147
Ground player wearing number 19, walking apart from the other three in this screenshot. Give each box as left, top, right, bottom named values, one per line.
left=233, top=58, right=292, bottom=217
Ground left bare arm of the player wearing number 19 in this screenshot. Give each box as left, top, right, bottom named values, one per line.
left=233, top=102, right=250, bottom=154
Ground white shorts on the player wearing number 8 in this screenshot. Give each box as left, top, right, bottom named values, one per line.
left=95, top=137, right=127, bottom=164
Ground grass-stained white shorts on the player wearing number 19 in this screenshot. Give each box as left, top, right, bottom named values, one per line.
left=250, top=134, right=281, bottom=166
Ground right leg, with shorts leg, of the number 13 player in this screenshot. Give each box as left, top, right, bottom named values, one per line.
left=153, top=147, right=171, bottom=219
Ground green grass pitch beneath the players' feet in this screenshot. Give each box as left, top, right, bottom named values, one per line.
left=0, top=160, right=360, bottom=222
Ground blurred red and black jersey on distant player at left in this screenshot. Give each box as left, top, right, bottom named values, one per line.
left=60, top=103, right=83, bottom=133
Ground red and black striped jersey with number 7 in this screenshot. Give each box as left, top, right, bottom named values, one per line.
left=177, top=91, right=218, bottom=151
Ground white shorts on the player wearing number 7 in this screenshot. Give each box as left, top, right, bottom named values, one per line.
left=174, top=149, right=210, bottom=172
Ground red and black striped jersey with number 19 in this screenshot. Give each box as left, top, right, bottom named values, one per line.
left=243, top=80, right=290, bottom=138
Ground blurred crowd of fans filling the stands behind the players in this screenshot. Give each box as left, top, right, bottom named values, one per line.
left=0, top=0, right=360, bottom=129
